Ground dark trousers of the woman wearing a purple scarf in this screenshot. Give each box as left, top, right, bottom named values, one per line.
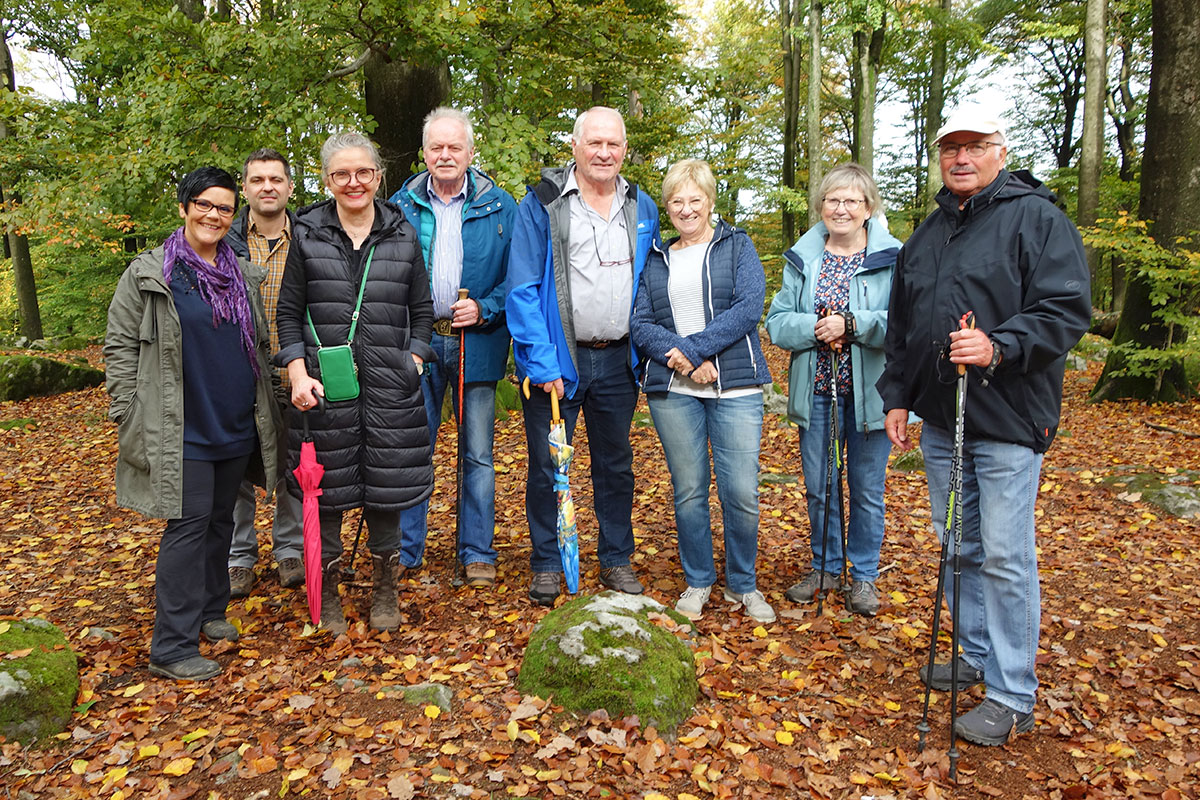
left=150, top=455, right=250, bottom=664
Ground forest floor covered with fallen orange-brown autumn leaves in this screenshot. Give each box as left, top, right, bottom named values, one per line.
left=0, top=345, right=1200, bottom=800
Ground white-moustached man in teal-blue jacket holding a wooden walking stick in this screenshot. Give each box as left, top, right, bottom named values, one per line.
left=391, top=107, right=517, bottom=587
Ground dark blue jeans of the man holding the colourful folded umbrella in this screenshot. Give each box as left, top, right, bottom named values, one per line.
left=521, top=344, right=637, bottom=572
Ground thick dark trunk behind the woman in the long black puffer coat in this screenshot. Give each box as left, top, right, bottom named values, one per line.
left=362, top=53, right=450, bottom=198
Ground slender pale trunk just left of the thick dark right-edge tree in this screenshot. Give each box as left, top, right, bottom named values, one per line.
left=1075, top=0, right=1108, bottom=306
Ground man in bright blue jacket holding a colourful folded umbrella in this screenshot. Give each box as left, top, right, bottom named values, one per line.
left=505, top=107, right=659, bottom=606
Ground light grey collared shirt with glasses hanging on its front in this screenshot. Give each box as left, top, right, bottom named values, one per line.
left=563, top=168, right=634, bottom=342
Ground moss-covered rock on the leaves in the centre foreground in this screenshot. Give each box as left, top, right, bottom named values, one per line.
left=517, top=591, right=700, bottom=729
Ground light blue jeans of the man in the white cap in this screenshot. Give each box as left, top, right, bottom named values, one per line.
left=920, top=422, right=1042, bottom=712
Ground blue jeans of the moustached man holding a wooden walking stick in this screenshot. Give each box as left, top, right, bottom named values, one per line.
left=400, top=333, right=496, bottom=567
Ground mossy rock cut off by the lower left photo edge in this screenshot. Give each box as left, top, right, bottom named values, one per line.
left=0, top=619, right=79, bottom=742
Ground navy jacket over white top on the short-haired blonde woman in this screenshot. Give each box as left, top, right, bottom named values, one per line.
left=630, top=221, right=770, bottom=392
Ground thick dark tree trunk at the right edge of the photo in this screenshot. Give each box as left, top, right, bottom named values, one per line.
left=1092, top=0, right=1200, bottom=402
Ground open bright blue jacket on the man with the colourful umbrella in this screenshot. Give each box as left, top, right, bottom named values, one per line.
left=505, top=164, right=659, bottom=397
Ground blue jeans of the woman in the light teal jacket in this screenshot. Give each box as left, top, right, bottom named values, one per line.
left=800, top=395, right=892, bottom=583
